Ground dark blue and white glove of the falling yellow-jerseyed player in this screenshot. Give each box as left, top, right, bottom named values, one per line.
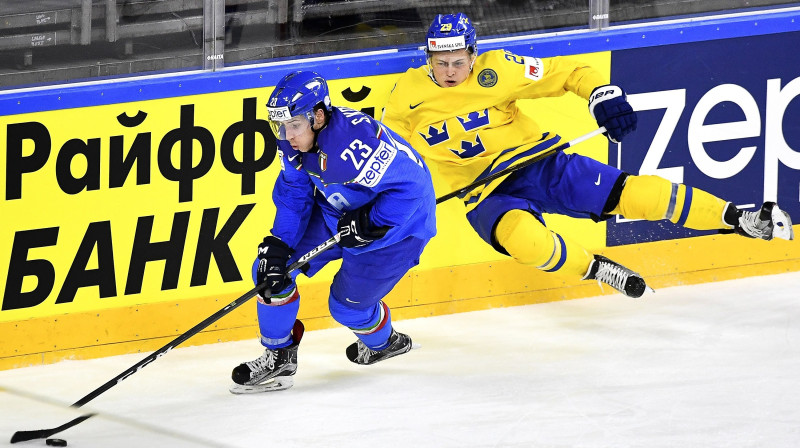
left=589, top=84, right=636, bottom=143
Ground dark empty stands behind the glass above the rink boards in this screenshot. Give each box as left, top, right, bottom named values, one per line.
left=0, top=0, right=795, bottom=89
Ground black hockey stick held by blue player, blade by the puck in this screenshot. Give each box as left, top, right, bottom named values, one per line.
left=11, top=233, right=343, bottom=443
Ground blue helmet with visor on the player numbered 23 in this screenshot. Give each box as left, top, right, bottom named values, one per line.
left=267, top=71, right=333, bottom=140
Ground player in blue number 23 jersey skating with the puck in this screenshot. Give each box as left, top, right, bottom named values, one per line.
left=231, top=71, right=436, bottom=393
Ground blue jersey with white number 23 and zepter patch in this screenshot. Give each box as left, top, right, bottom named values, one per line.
left=272, top=107, right=436, bottom=253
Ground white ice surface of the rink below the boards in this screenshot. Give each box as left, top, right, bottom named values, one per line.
left=0, top=272, right=800, bottom=448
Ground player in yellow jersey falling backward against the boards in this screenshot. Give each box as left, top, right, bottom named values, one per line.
left=383, top=13, right=794, bottom=297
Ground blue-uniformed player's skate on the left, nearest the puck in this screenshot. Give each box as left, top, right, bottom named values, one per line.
left=230, top=320, right=304, bottom=394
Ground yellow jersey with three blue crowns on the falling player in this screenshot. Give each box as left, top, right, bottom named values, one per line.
left=382, top=50, right=608, bottom=211
